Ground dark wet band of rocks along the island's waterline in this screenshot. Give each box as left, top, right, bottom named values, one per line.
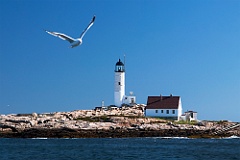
left=0, top=128, right=236, bottom=138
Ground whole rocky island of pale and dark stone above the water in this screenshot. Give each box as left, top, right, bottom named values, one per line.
left=0, top=105, right=240, bottom=138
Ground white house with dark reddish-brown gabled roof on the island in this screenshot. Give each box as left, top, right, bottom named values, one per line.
left=145, top=95, right=182, bottom=120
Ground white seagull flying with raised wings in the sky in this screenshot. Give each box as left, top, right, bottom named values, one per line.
left=45, top=15, right=95, bottom=48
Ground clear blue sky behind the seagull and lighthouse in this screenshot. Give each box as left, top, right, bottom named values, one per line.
left=0, top=0, right=240, bottom=121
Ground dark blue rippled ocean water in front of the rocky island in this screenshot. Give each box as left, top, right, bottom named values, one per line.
left=0, top=137, right=240, bottom=160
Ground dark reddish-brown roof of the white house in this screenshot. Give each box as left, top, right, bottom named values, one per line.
left=146, top=95, right=180, bottom=109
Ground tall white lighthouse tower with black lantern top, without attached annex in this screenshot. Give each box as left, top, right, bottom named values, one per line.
left=114, top=59, right=125, bottom=107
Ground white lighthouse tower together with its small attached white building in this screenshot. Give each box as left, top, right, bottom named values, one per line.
left=114, top=59, right=136, bottom=107
